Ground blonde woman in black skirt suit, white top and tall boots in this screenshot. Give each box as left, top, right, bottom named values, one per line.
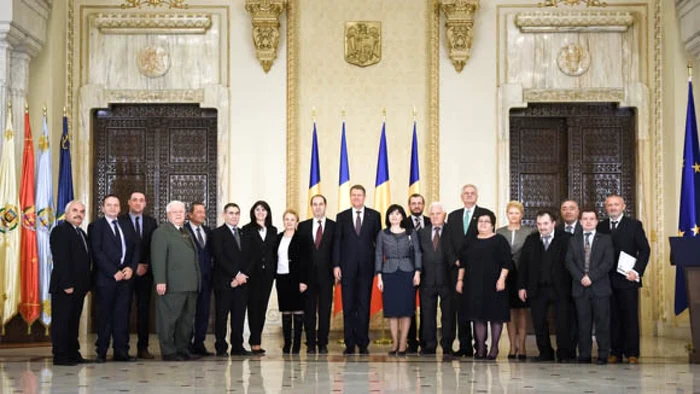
left=275, top=209, right=307, bottom=354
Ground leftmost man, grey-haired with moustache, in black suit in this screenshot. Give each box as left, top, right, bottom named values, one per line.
left=49, top=201, right=91, bottom=365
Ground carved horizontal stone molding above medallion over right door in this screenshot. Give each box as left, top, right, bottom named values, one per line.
left=515, top=11, right=634, bottom=33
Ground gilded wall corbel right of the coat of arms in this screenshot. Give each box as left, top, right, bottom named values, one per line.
left=440, top=0, right=479, bottom=72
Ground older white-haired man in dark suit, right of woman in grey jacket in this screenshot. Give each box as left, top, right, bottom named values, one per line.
left=418, top=202, right=455, bottom=357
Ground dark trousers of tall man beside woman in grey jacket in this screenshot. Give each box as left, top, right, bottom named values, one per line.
left=341, top=273, right=373, bottom=348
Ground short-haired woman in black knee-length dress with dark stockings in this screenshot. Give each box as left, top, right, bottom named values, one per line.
left=456, top=212, right=513, bottom=360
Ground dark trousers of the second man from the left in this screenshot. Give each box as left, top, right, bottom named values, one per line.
left=95, top=280, right=134, bottom=357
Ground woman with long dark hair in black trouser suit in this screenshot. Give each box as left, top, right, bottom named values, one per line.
left=241, top=201, right=277, bottom=354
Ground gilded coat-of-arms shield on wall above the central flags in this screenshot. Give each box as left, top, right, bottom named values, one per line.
left=345, top=22, right=382, bottom=67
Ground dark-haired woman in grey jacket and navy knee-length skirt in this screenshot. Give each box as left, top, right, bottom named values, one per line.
left=374, top=204, right=421, bottom=356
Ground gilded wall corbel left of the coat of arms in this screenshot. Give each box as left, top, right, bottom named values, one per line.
left=245, top=0, right=286, bottom=73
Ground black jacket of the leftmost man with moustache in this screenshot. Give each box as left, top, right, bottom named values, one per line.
left=49, top=221, right=92, bottom=294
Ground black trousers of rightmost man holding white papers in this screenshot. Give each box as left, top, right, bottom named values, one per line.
left=610, top=288, right=639, bottom=358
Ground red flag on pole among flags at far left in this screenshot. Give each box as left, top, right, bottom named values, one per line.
left=19, top=110, right=41, bottom=331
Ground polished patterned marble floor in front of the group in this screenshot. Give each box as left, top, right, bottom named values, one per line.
left=0, top=336, right=700, bottom=394
